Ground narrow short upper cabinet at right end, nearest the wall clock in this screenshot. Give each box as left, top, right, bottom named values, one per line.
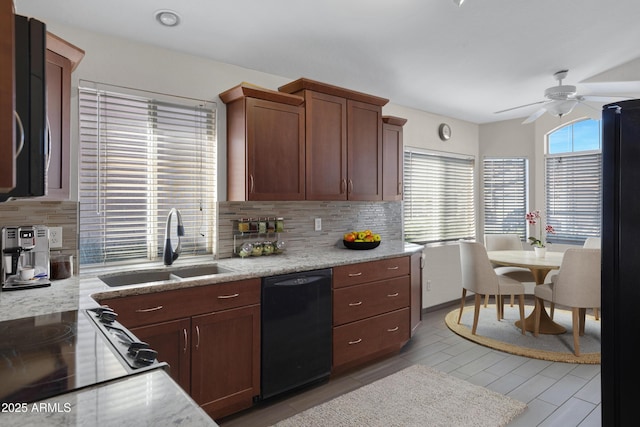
left=382, top=116, right=407, bottom=201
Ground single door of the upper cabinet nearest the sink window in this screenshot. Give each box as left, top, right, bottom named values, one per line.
left=246, top=98, right=305, bottom=200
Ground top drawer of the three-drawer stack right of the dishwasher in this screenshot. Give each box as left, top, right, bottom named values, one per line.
left=333, top=257, right=409, bottom=288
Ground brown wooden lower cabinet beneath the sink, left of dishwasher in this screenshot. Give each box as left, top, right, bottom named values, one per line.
left=99, top=279, right=260, bottom=419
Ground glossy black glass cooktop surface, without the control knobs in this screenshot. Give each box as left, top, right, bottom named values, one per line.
left=0, top=311, right=146, bottom=403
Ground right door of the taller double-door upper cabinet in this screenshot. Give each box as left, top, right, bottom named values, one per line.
left=347, top=100, right=382, bottom=201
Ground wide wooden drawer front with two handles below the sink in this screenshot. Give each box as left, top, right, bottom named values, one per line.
left=100, top=279, right=260, bottom=328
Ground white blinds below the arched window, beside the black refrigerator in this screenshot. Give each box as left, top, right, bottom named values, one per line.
left=546, top=152, right=602, bottom=244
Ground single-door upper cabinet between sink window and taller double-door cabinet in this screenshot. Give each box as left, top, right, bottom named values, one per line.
left=220, top=84, right=305, bottom=201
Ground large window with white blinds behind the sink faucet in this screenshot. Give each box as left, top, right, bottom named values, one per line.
left=78, top=85, right=216, bottom=265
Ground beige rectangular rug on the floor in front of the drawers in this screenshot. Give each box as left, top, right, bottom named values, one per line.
left=276, top=365, right=527, bottom=427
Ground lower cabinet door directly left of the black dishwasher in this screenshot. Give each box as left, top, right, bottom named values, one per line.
left=191, top=305, right=260, bottom=419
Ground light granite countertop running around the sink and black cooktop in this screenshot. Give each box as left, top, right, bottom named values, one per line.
left=0, top=242, right=422, bottom=426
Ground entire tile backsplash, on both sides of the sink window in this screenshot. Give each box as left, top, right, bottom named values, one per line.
left=0, top=199, right=402, bottom=266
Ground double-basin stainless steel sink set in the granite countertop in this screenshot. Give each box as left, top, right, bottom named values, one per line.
left=98, top=264, right=231, bottom=287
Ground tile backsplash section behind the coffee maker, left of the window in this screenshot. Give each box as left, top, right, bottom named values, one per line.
left=0, top=199, right=79, bottom=274
